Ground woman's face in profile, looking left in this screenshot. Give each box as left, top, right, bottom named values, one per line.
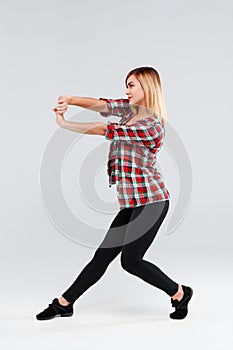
left=126, top=74, right=145, bottom=106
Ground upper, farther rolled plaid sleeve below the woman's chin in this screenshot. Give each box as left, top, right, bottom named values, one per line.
left=99, top=97, right=131, bottom=117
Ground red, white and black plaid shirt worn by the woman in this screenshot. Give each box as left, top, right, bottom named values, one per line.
left=99, top=97, right=170, bottom=209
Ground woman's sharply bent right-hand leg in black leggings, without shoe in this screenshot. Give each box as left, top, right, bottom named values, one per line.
left=121, top=200, right=179, bottom=296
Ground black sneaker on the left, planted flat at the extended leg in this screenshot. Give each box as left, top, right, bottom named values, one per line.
left=36, top=298, right=74, bottom=320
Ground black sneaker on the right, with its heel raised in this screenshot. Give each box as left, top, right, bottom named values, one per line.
left=169, top=285, right=193, bottom=320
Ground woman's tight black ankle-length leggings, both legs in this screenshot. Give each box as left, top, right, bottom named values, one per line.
left=62, top=200, right=179, bottom=303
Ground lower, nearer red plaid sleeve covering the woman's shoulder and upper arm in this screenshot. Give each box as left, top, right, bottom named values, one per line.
left=104, top=121, right=164, bottom=148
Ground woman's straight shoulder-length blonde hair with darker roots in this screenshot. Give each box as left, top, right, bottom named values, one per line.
left=125, top=67, right=167, bottom=126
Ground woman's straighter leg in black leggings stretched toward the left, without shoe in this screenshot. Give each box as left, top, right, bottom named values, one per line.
left=62, top=208, right=132, bottom=303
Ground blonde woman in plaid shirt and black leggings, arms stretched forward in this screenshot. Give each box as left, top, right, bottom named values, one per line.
left=36, top=67, right=193, bottom=320
